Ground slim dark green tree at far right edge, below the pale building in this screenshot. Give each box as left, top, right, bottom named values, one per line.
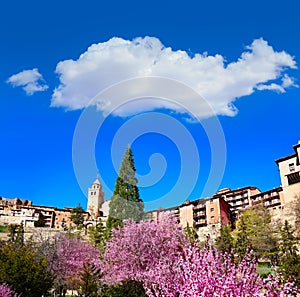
left=279, top=221, right=300, bottom=286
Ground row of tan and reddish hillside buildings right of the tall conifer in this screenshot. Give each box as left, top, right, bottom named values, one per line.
left=146, top=141, right=300, bottom=239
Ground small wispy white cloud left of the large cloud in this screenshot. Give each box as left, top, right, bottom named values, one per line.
left=7, top=68, right=48, bottom=95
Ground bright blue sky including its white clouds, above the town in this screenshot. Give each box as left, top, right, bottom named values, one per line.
left=0, top=0, right=300, bottom=209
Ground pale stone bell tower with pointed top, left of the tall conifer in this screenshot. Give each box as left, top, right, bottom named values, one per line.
left=87, top=176, right=104, bottom=219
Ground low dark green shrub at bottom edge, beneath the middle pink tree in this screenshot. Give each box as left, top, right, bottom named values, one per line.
left=100, top=280, right=148, bottom=297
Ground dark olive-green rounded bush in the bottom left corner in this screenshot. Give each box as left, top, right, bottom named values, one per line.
left=0, top=244, right=52, bottom=297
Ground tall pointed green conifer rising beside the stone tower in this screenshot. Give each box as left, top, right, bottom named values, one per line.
left=106, top=146, right=144, bottom=229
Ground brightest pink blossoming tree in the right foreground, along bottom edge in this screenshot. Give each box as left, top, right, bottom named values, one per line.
left=144, top=245, right=297, bottom=297
